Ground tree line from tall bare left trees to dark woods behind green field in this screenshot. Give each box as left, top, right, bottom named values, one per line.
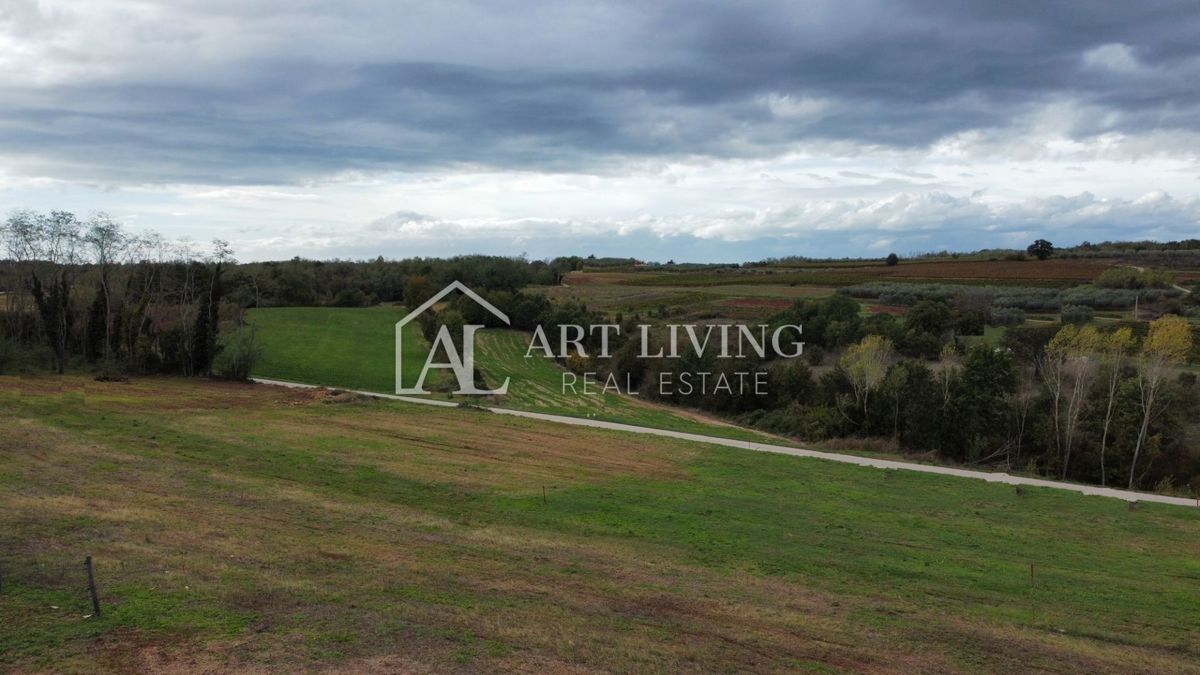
left=0, top=210, right=589, bottom=377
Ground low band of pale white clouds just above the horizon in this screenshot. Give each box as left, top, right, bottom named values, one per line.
left=231, top=192, right=1200, bottom=261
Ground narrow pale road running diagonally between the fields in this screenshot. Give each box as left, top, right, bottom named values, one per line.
left=251, top=377, right=1200, bottom=507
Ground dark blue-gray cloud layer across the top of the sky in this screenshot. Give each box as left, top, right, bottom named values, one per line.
left=0, top=0, right=1200, bottom=184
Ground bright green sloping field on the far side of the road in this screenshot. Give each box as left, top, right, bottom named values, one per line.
left=247, top=306, right=766, bottom=440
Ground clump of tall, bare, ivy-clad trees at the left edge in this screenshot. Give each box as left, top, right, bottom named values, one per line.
left=0, top=210, right=236, bottom=375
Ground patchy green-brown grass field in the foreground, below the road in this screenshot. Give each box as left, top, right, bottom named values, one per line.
left=0, top=377, right=1200, bottom=673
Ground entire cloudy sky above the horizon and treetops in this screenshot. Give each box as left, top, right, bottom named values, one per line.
left=0, top=0, right=1200, bottom=261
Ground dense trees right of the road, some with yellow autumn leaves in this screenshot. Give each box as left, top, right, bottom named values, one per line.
left=564, top=295, right=1200, bottom=491
